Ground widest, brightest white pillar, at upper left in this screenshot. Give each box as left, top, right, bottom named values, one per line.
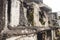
left=10, top=0, right=20, bottom=26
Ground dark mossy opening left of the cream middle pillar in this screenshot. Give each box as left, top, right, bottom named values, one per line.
left=27, top=7, right=34, bottom=26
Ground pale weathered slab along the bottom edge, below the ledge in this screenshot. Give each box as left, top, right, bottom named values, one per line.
left=6, top=34, right=37, bottom=40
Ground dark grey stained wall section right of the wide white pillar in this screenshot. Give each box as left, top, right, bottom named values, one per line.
left=19, top=2, right=26, bottom=25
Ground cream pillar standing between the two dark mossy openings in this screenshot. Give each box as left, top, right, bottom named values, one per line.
left=33, top=3, right=41, bottom=26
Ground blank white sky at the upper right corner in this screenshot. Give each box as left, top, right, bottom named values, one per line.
left=43, top=0, right=60, bottom=12
